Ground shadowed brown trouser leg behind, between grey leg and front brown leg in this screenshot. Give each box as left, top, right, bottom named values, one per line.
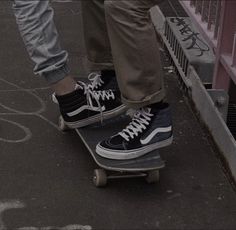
left=81, top=0, right=114, bottom=71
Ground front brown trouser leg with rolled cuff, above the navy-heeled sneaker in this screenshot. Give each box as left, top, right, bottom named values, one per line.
left=105, top=0, right=165, bottom=108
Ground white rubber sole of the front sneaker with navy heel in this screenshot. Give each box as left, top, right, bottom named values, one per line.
left=96, top=136, right=173, bottom=160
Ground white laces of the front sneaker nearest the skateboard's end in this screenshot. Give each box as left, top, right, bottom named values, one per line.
left=119, top=108, right=154, bottom=141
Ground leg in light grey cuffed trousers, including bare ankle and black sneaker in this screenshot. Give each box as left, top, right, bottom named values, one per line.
left=13, top=0, right=127, bottom=128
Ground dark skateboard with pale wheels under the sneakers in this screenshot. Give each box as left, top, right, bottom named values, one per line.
left=59, top=114, right=165, bottom=187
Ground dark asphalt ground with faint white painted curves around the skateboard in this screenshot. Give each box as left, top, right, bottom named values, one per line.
left=0, top=1, right=236, bottom=230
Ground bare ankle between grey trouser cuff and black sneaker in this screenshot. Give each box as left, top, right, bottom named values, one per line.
left=51, top=76, right=76, bottom=96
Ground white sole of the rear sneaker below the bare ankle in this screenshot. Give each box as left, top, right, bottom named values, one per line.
left=64, top=105, right=127, bottom=129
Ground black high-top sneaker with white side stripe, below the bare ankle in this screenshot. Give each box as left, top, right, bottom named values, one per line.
left=55, top=83, right=126, bottom=129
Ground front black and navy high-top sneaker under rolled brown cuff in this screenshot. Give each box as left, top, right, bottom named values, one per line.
left=96, top=103, right=173, bottom=160
